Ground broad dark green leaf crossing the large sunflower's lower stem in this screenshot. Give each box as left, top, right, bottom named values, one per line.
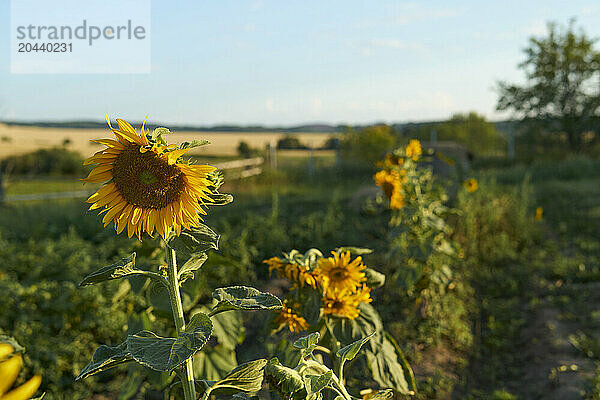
left=126, top=313, right=212, bottom=371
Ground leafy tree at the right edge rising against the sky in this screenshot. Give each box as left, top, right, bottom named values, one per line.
left=496, top=20, right=600, bottom=151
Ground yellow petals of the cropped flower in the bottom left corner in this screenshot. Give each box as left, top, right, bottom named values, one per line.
left=0, top=343, right=42, bottom=400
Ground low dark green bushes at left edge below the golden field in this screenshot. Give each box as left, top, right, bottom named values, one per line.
left=0, top=147, right=87, bottom=176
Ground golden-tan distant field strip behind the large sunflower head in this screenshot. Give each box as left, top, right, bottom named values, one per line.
left=0, top=123, right=331, bottom=159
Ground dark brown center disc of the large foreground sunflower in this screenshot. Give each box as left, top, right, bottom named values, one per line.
left=113, top=145, right=185, bottom=209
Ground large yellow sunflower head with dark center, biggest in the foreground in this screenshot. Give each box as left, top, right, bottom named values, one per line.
left=83, top=117, right=216, bottom=238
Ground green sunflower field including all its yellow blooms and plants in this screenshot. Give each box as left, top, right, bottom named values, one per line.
left=0, top=119, right=600, bottom=400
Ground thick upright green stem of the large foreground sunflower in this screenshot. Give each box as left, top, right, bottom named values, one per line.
left=165, top=245, right=196, bottom=400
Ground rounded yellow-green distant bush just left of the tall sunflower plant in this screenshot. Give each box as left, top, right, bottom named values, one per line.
left=340, top=125, right=396, bottom=163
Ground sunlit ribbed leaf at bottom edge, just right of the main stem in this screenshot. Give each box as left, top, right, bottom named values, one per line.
left=204, top=359, right=267, bottom=398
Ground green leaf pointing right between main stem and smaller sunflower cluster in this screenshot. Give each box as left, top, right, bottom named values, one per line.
left=211, top=286, right=283, bottom=315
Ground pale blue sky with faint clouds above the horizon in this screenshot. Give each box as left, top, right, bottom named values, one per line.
left=0, top=0, right=600, bottom=126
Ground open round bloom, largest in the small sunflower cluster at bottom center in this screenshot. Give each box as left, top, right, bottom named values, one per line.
left=314, top=251, right=367, bottom=292
